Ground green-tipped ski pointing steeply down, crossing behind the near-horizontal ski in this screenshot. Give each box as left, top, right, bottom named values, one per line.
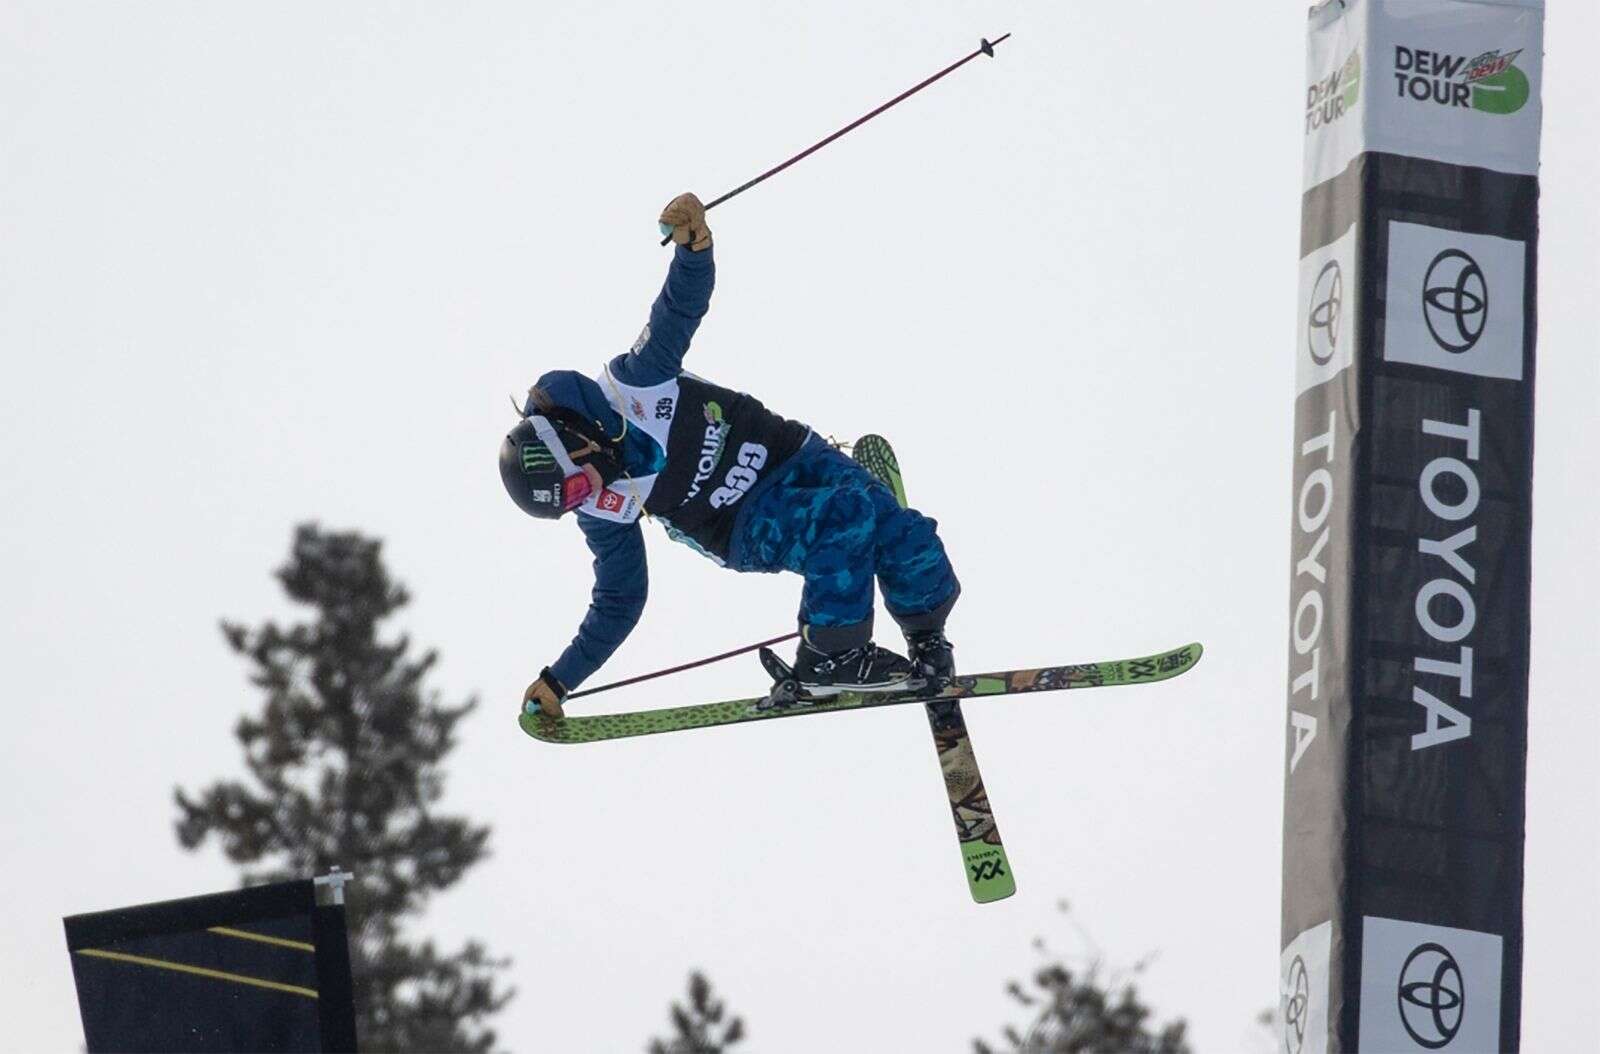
left=850, top=435, right=1016, bottom=904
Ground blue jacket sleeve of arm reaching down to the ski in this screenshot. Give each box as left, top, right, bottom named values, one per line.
left=550, top=515, right=650, bottom=691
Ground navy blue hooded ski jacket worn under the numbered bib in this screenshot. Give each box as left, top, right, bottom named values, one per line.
left=537, top=245, right=806, bottom=689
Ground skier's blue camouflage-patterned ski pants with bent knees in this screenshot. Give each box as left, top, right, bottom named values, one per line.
left=731, top=440, right=962, bottom=651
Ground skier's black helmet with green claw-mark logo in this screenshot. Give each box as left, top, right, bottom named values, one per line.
left=499, top=406, right=622, bottom=520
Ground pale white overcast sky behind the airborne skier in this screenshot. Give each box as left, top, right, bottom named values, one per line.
left=0, top=0, right=1600, bottom=1054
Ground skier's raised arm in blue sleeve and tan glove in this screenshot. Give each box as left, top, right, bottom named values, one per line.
left=611, top=194, right=717, bottom=387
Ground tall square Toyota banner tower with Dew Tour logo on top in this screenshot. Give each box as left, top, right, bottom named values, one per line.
left=1278, top=0, right=1544, bottom=1054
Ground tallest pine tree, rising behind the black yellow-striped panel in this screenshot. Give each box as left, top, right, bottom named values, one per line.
left=174, top=525, right=512, bottom=1051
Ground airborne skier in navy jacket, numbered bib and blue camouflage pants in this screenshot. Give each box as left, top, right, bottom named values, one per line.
left=499, top=194, right=960, bottom=717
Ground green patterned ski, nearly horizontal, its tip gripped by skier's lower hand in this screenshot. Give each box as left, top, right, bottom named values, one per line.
left=520, top=645, right=1203, bottom=744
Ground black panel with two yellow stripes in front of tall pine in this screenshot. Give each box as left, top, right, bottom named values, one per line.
left=66, top=872, right=355, bottom=1052
